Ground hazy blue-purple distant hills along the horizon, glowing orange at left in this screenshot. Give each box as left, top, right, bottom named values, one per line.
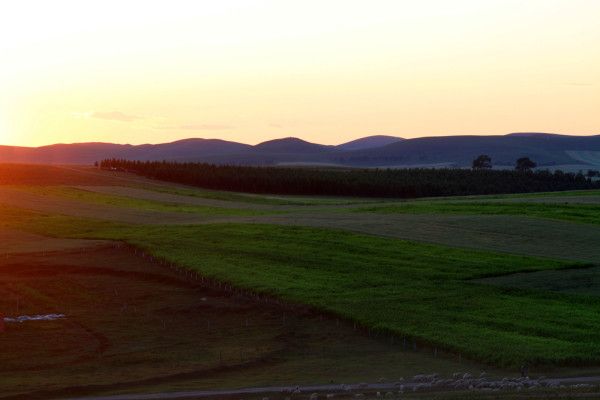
left=0, top=133, right=600, bottom=169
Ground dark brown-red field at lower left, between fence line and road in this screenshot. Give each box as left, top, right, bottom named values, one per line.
left=0, top=244, right=494, bottom=398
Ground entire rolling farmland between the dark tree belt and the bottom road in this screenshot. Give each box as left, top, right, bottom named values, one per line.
left=0, top=166, right=600, bottom=398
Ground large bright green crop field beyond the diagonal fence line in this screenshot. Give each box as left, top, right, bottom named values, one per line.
left=108, top=225, right=600, bottom=365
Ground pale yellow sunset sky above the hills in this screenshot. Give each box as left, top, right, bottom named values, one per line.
left=0, top=0, right=600, bottom=146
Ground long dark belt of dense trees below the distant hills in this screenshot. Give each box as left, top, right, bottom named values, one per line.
left=100, top=159, right=600, bottom=198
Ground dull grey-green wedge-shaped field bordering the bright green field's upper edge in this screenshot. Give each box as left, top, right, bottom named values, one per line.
left=244, top=212, right=600, bottom=263
